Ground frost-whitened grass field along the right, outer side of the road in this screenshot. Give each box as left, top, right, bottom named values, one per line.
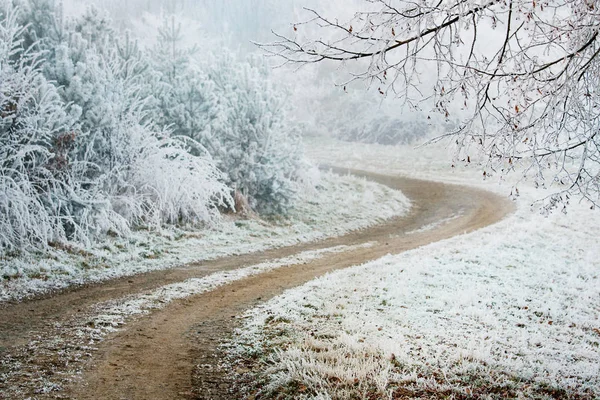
left=227, top=138, right=600, bottom=399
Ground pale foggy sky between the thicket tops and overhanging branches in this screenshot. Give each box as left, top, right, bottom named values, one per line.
left=64, top=0, right=453, bottom=144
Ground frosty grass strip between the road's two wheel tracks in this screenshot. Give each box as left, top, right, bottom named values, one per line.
left=0, top=243, right=372, bottom=398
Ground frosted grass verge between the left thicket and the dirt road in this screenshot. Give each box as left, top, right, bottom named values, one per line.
left=0, top=173, right=409, bottom=301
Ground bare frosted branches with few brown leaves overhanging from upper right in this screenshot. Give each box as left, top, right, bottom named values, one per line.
left=265, top=0, right=600, bottom=206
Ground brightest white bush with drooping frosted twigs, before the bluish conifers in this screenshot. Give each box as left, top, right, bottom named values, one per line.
left=114, top=127, right=232, bottom=227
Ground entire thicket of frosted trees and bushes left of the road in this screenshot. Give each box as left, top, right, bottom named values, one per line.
left=0, top=0, right=305, bottom=254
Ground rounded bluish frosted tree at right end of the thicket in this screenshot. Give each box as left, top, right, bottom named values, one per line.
left=204, top=55, right=306, bottom=213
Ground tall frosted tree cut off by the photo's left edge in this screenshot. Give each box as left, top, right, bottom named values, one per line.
left=0, top=1, right=73, bottom=253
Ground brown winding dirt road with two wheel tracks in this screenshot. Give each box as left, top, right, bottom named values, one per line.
left=0, top=170, right=513, bottom=400
